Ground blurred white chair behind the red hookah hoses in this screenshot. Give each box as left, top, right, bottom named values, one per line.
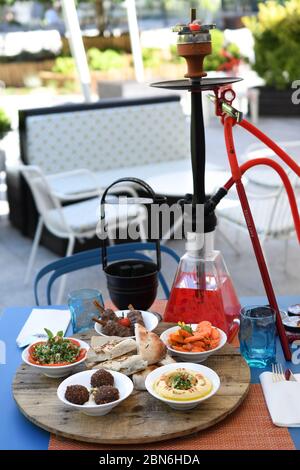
left=216, top=172, right=299, bottom=264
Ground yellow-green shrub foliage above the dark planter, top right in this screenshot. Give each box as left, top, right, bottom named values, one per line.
left=243, top=0, right=300, bottom=90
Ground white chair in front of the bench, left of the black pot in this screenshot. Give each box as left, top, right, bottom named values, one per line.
left=21, top=165, right=146, bottom=303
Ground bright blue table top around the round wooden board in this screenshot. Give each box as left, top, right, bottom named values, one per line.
left=0, top=296, right=300, bottom=450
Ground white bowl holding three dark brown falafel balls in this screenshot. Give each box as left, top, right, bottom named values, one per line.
left=57, top=370, right=133, bottom=416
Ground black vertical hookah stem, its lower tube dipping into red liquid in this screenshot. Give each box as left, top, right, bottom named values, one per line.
left=191, top=90, right=205, bottom=300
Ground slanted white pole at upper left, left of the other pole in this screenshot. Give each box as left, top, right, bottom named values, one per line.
left=62, top=0, right=91, bottom=102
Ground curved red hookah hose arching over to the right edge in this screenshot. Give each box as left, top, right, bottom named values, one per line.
left=223, top=158, right=300, bottom=243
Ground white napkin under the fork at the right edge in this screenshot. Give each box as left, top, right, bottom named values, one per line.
left=259, top=372, right=300, bottom=428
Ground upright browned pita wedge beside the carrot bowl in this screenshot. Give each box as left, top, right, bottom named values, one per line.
left=134, top=323, right=167, bottom=366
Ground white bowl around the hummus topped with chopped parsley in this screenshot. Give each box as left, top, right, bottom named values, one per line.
left=145, top=362, right=220, bottom=410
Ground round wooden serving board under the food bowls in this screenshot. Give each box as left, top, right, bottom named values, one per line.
left=13, top=323, right=250, bottom=444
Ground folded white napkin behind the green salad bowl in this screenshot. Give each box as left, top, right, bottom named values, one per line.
left=16, top=308, right=71, bottom=347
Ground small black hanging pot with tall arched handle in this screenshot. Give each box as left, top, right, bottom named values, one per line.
left=101, top=177, right=166, bottom=310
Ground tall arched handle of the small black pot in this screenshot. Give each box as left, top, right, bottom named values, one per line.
left=100, top=177, right=165, bottom=271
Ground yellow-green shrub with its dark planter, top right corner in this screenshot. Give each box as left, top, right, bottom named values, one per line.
left=244, top=0, right=300, bottom=116
